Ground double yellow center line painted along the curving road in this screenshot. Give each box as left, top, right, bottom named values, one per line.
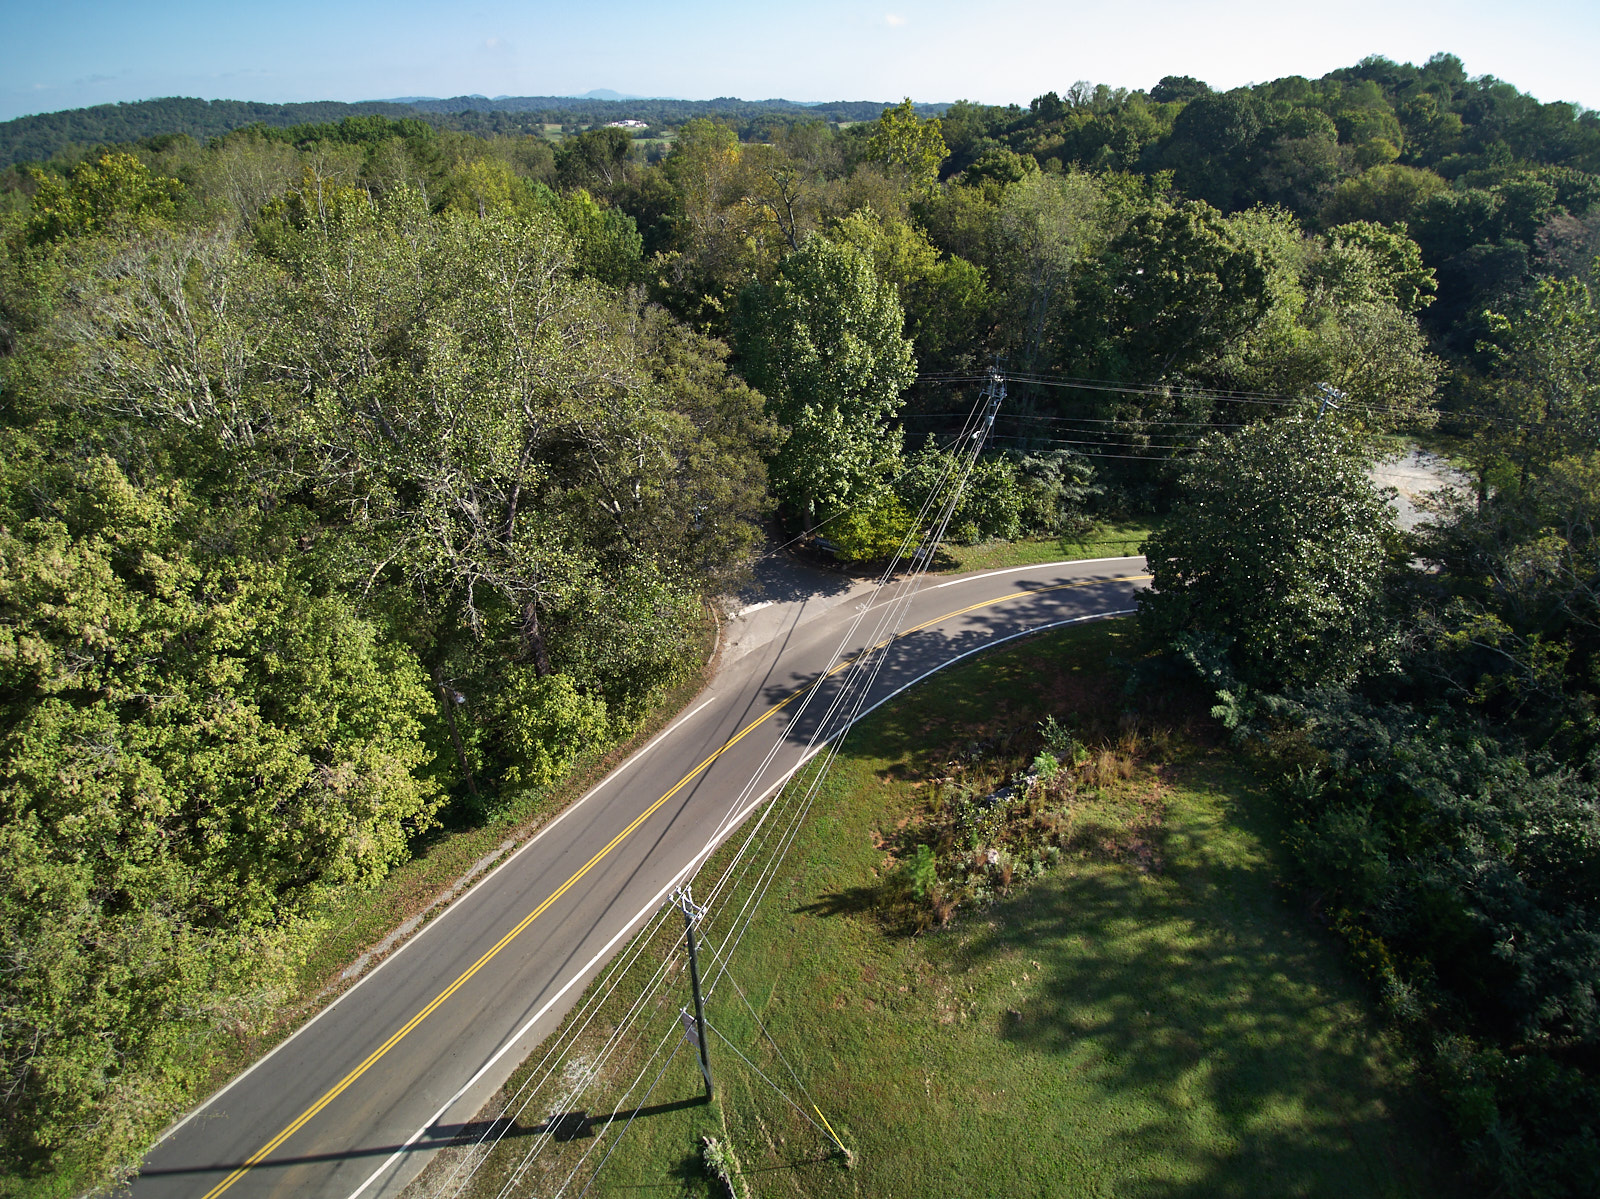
left=202, top=575, right=1149, bottom=1199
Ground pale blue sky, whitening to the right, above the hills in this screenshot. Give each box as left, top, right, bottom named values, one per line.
left=0, top=0, right=1600, bottom=120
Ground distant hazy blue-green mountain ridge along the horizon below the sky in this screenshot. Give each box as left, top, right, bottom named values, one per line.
left=0, top=88, right=947, bottom=166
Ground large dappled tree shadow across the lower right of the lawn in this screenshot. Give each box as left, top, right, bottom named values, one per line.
left=946, top=864, right=1454, bottom=1199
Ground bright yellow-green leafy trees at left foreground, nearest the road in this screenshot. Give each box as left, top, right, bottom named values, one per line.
left=0, top=458, right=440, bottom=1165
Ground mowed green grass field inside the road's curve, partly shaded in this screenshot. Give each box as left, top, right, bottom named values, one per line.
left=441, top=621, right=1456, bottom=1199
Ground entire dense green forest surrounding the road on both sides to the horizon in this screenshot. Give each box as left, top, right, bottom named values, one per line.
left=0, top=54, right=1600, bottom=1196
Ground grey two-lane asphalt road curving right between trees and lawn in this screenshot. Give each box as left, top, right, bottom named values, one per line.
left=133, top=559, right=1144, bottom=1199
